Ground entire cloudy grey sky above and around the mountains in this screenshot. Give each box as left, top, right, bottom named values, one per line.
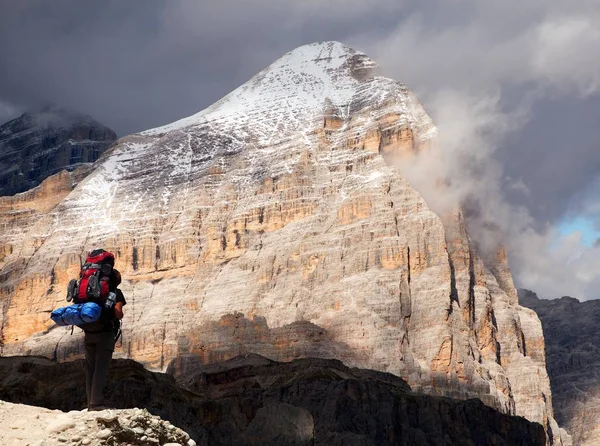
left=0, top=0, right=600, bottom=300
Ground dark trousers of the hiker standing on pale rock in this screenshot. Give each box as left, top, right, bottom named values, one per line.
left=85, top=331, right=115, bottom=409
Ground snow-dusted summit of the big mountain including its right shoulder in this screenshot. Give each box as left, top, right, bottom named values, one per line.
left=143, top=42, right=437, bottom=152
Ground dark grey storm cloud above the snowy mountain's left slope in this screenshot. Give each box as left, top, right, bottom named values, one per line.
left=0, top=0, right=404, bottom=135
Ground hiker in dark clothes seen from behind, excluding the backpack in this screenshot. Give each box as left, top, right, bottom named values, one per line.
left=81, top=268, right=127, bottom=411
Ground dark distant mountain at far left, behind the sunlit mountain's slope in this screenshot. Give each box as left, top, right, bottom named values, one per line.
left=0, top=107, right=117, bottom=196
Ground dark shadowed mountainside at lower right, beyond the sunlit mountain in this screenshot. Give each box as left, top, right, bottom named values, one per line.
left=519, top=290, right=600, bottom=446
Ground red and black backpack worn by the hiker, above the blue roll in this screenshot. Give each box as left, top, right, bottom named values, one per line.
left=67, top=249, right=115, bottom=305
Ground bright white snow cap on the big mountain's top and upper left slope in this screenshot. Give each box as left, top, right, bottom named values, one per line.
left=143, top=41, right=377, bottom=135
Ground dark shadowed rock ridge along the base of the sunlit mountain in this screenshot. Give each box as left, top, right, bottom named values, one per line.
left=0, top=355, right=546, bottom=446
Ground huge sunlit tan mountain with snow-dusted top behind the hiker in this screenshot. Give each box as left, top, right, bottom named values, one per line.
left=0, top=42, right=561, bottom=442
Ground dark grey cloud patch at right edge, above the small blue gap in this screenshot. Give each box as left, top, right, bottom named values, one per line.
left=496, top=96, right=600, bottom=223
